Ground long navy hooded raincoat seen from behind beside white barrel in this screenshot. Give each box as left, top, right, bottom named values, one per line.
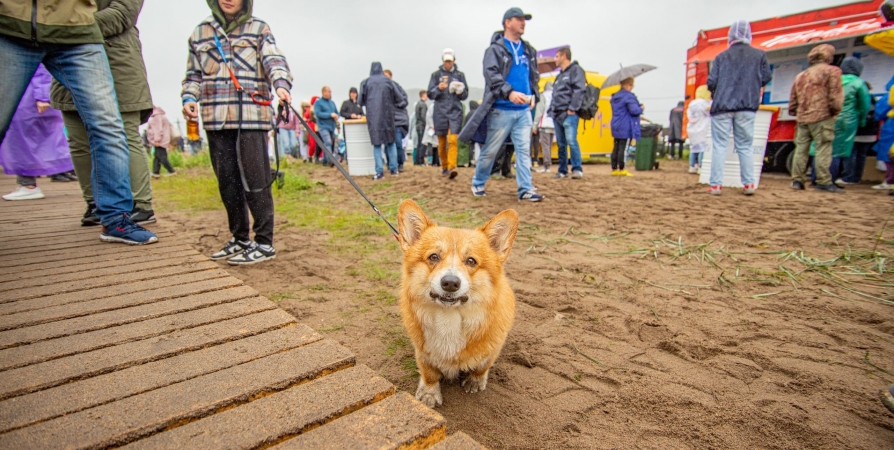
left=360, top=62, right=407, bottom=145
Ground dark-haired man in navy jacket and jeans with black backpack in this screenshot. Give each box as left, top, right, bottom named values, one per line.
left=549, top=47, right=587, bottom=179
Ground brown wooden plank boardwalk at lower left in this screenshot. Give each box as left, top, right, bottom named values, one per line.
left=0, top=176, right=480, bottom=449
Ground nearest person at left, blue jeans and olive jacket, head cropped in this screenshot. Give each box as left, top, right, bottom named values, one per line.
left=0, top=0, right=158, bottom=245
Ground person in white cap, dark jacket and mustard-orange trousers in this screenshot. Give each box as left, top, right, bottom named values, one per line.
left=428, top=48, right=469, bottom=180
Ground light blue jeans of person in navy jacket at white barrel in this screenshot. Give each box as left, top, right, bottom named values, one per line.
left=711, top=111, right=757, bottom=186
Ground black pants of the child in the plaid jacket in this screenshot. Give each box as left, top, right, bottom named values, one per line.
left=207, top=130, right=273, bottom=245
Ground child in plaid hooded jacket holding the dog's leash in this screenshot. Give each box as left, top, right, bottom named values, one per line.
left=181, top=0, right=292, bottom=265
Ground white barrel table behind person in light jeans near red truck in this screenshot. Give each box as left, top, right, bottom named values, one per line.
left=698, top=108, right=775, bottom=188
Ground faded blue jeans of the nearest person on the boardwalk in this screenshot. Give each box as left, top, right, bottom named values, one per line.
left=0, top=35, right=133, bottom=225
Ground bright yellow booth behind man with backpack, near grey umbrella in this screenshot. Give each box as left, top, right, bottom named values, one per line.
left=540, top=72, right=621, bottom=161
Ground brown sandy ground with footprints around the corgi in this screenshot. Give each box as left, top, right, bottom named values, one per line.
left=159, top=162, right=894, bottom=449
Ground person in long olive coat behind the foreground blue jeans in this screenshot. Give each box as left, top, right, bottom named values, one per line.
left=51, top=0, right=155, bottom=226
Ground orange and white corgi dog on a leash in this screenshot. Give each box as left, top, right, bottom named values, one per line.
left=397, top=200, right=518, bottom=408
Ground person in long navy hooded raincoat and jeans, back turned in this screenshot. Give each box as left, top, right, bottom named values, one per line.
left=360, top=62, right=407, bottom=180
